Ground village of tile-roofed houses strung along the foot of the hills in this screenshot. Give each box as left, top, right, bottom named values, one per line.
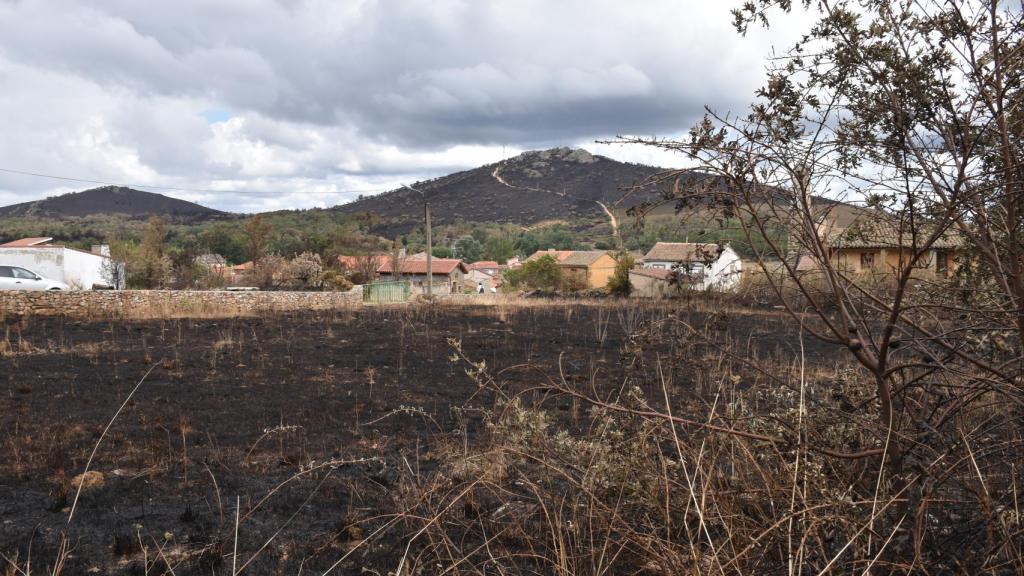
left=0, top=211, right=963, bottom=302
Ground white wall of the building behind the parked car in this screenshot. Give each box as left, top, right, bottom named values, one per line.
left=0, top=246, right=124, bottom=290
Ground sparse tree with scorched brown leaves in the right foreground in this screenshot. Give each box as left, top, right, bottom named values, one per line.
left=614, top=0, right=1024, bottom=572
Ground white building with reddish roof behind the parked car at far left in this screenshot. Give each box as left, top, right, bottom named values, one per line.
left=0, top=238, right=125, bottom=290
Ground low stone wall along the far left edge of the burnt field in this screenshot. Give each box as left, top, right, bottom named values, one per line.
left=0, top=288, right=362, bottom=319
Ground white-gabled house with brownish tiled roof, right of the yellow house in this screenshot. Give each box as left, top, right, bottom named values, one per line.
left=643, top=242, right=742, bottom=290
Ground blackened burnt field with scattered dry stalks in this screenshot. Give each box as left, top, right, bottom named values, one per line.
left=0, top=304, right=835, bottom=575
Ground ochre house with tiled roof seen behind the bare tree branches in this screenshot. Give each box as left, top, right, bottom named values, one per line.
left=823, top=217, right=963, bottom=277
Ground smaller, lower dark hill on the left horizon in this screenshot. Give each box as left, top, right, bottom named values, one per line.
left=0, top=186, right=231, bottom=222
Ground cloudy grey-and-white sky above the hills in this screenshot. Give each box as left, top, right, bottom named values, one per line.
left=0, top=0, right=811, bottom=211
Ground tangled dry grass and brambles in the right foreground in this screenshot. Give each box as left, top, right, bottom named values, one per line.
left=385, top=317, right=1024, bottom=576
